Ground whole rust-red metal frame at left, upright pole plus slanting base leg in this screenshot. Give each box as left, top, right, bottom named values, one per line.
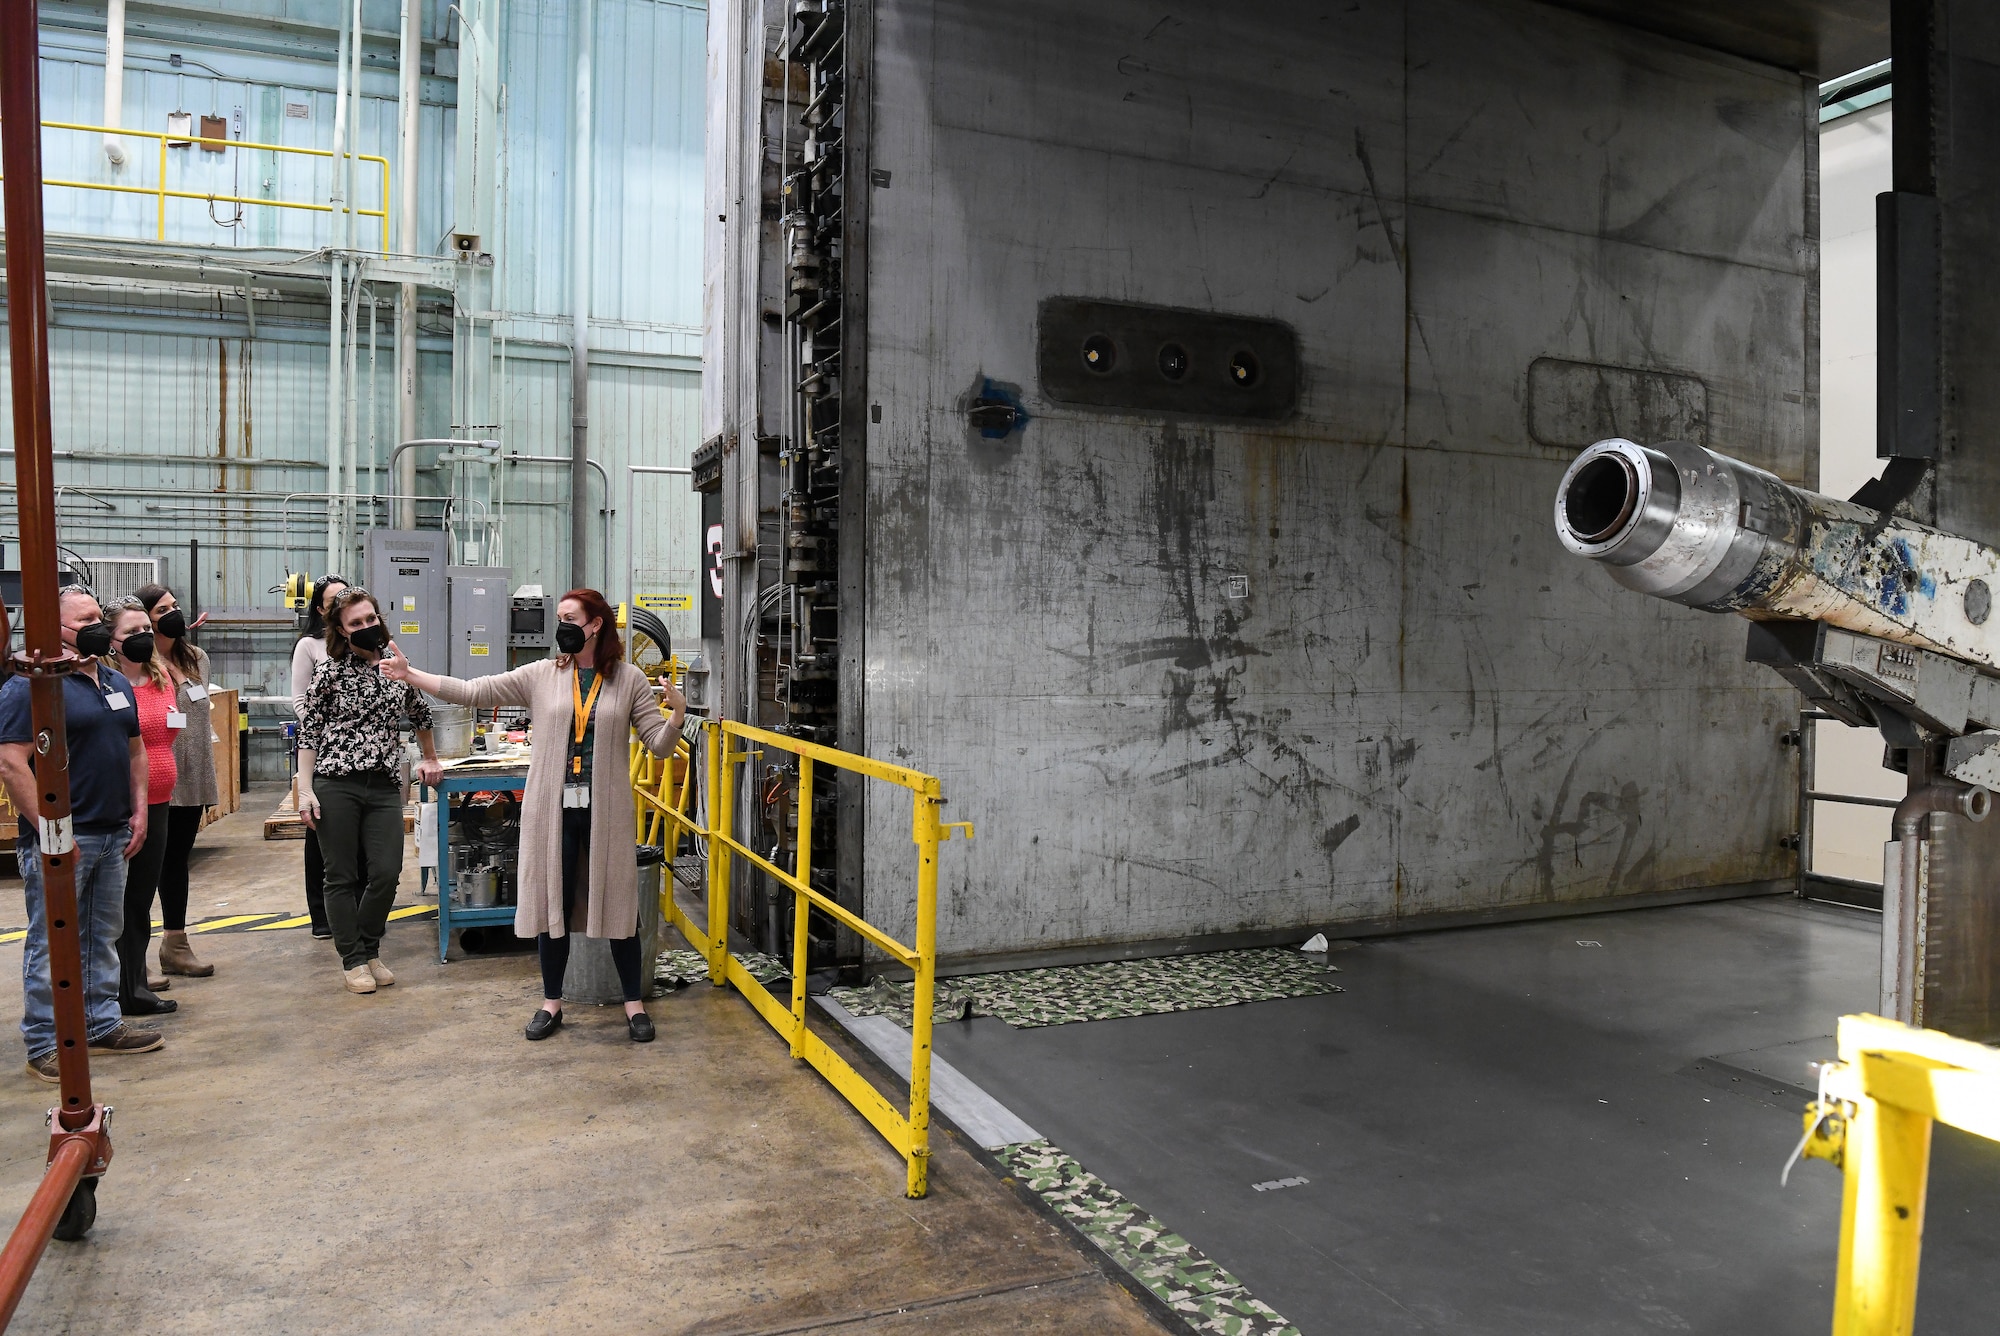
left=0, top=4, right=112, bottom=1326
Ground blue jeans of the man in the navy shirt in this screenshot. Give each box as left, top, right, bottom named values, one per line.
left=18, top=826, right=132, bottom=1062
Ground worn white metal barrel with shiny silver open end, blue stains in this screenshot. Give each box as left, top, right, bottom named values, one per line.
left=1556, top=440, right=2000, bottom=668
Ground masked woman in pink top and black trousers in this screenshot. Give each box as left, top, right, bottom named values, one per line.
left=110, top=598, right=188, bottom=1016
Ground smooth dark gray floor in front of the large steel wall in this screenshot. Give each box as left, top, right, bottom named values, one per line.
left=938, top=898, right=2000, bottom=1336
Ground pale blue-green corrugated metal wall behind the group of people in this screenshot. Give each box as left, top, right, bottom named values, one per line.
left=0, top=0, right=706, bottom=690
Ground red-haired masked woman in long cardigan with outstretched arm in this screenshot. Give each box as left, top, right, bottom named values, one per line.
left=382, top=590, right=688, bottom=1044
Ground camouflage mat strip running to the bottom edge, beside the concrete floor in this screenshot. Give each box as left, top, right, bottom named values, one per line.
left=994, top=1142, right=1298, bottom=1336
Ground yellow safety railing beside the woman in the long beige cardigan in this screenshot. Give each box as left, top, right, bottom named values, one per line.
left=632, top=720, right=972, bottom=1196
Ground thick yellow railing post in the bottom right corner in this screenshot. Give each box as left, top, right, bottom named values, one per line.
left=1802, top=1016, right=2000, bottom=1336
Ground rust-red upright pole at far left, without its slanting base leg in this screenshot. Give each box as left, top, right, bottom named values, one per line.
left=0, top=4, right=94, bottom=1128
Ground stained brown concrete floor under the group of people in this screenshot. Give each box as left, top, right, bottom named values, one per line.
left=0, top=792, right=1162, bottom=1334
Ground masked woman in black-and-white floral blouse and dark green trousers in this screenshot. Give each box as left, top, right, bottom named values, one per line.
left=298, top=588, right=444, bottom=992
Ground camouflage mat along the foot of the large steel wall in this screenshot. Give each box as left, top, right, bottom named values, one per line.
left=828, top=946, right=1342, bottom=1030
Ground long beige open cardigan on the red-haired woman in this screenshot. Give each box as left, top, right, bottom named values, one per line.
left=434, top=658, right=676, bottom=938
